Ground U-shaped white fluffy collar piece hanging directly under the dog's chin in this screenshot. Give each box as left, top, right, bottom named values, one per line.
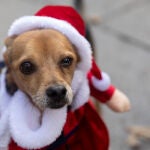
left=10, top=91, right=67, bottom=149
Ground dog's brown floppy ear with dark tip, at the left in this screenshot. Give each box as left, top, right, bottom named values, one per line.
left=3, top=36, right=17, bottom=95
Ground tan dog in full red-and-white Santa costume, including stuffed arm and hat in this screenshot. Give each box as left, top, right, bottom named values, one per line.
left=0, top=6, right=130, bottom=150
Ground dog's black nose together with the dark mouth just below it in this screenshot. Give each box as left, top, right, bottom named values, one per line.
left=46, top=85, right=68, bottom=109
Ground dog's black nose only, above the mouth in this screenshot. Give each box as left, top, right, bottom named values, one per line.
left=46, top=85, right=67, bottom=101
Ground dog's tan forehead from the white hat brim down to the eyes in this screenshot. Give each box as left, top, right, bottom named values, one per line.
left=9, top=29, right=77, bottom=64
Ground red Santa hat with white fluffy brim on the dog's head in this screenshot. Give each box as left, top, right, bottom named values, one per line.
left=5, top=6, right=91, bottom=72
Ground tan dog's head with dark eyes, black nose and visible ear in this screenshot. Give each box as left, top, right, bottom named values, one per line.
left=4, top=29, right=79, bottom=110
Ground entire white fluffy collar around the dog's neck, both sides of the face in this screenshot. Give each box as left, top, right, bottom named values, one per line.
left=0, top=70, right=89, bottom=149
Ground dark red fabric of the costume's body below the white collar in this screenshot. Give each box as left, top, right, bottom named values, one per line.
left=9, top=102, right=109, bottom=150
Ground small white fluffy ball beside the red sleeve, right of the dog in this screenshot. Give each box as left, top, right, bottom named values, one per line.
left=92, top=72, right=111, bottom=91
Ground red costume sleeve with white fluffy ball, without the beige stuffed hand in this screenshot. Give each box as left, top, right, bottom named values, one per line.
left=87, top=60, right=115, bottom=103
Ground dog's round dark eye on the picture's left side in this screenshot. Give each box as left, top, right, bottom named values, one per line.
left=20, top=61, right=36, bottom=75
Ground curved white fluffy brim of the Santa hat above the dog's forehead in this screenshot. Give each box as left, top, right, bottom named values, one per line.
left=8, top=16, right=92, bottom=72
